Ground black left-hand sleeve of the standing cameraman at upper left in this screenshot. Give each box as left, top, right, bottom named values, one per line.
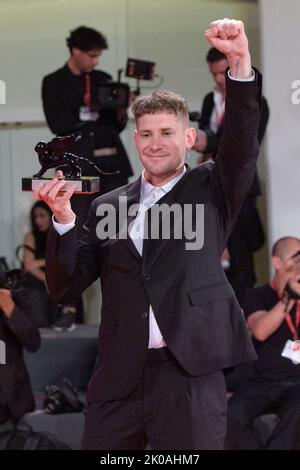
left=42, top=76, right=83, bottom=135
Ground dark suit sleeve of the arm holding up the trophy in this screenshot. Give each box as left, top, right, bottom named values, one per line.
left=45, top=203, right=100, bottom=304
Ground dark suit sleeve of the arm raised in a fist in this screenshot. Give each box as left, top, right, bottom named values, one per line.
left=212, top=72, right=261, bottom=243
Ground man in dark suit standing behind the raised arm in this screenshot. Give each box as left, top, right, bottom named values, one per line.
left=194, top=47, right=269, bottom=302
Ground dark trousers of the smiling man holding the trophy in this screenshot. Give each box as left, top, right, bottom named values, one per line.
left=82, top=348, right=227, bottom=450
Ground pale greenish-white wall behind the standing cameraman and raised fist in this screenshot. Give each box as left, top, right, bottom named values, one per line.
left=0, top=0, right=259, bottom=324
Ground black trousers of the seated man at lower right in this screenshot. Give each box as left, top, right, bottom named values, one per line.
left=225, top=376, right=300, bottom=450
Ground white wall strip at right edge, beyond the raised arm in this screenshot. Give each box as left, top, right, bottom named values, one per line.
left=259, top=0, right=300, bottom=248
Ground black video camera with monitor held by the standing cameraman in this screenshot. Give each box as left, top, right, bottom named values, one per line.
left=93, top=59, right=156, bottom=110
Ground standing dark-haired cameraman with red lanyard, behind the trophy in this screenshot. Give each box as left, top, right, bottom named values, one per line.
left=42, top=26, right=133, bottom=231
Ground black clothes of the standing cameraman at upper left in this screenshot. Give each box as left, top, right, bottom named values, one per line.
left=42, top=64, right=133, bottom=182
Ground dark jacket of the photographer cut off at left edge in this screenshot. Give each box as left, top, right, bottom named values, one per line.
left=0, top=290, right=41, bottom=420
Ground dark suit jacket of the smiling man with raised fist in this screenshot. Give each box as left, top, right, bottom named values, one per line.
left=46, top=71, right=261, bottom=402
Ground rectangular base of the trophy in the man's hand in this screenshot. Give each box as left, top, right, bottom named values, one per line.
left=22, top=176, right=100, bottom=194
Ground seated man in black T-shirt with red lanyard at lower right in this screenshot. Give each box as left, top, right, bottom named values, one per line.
left=226, top=237, right=300, bottom=450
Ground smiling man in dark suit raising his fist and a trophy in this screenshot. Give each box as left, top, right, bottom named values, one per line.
left=35, top=19, right=260, bottom=450
